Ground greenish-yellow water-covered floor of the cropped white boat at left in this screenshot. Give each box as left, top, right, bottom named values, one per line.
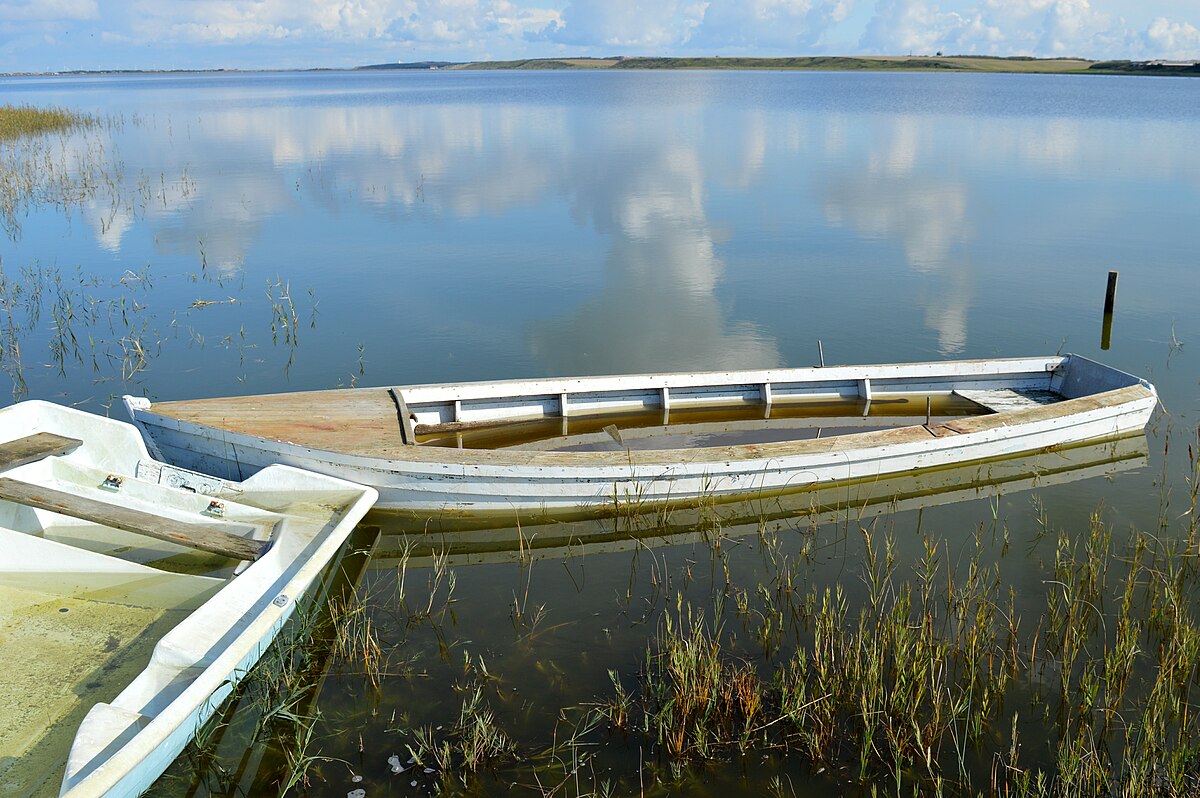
left=0, top=552, right=229, bottom=798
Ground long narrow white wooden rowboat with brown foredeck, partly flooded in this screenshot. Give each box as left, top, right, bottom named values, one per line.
left=125, top=355, right=1158, bottom=518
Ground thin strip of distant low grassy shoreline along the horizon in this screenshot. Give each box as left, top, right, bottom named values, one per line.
left=0, top=54, right=1200, bottom=78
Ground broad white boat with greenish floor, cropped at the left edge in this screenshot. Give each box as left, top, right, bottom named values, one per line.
left=0, top=402, right=376, bottom=798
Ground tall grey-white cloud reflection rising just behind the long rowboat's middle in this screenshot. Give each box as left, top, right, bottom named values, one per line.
left=529, top=135, right=780, bottom=373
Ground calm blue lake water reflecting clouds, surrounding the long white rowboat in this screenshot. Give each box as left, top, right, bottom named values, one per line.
left=0, top=72, right=1200, bottom=798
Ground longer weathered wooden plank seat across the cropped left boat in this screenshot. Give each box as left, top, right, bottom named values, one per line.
left=0, top=476, right=269, bottom=560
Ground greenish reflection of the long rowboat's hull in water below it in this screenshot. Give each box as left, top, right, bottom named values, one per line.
left=371, top=432, right=1150, bottom=559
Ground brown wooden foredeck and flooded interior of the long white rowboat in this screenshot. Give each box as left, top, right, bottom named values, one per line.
left=145, top=359, right=1075, bottom=460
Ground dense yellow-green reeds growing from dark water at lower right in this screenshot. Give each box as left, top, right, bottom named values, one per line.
left=583, top=463, right=1200, bottom=797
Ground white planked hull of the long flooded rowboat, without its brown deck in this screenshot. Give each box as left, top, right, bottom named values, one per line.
left=126, top=358, right=1157, bottom=516
